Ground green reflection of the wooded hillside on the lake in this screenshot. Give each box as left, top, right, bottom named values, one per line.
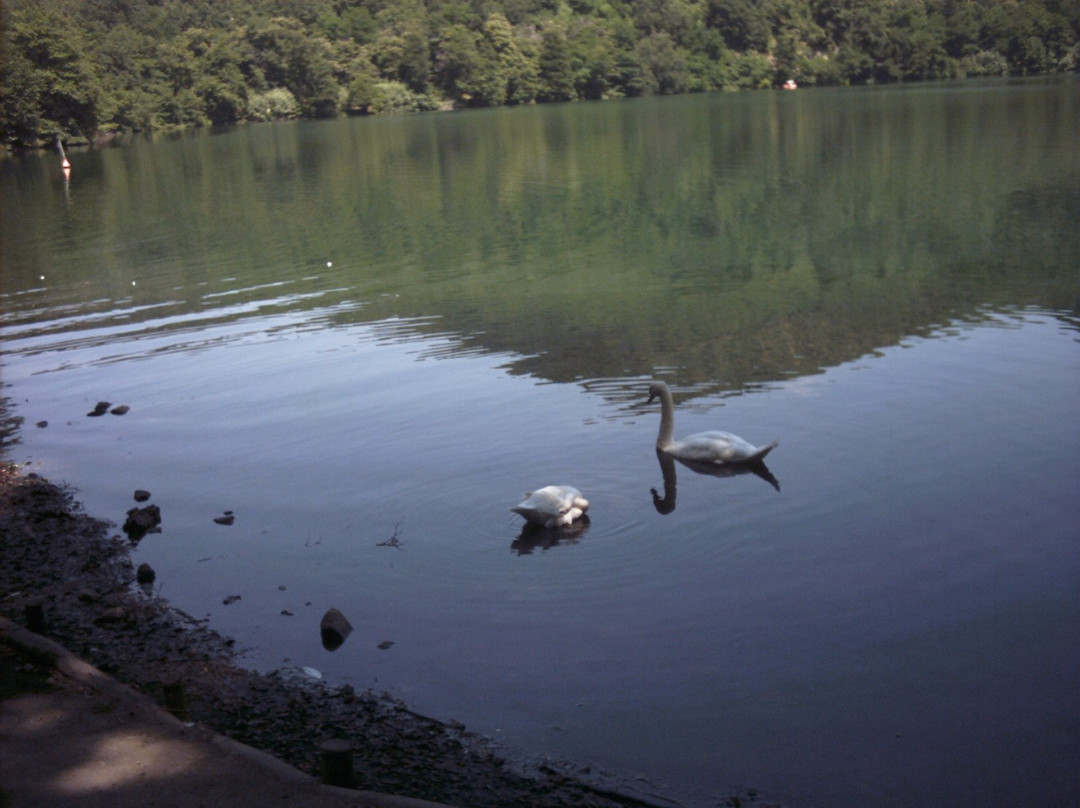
left=2, top=82, right=1080, bottom=391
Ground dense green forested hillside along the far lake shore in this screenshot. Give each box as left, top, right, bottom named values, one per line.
left=0, top=0, right=1080, bottom=146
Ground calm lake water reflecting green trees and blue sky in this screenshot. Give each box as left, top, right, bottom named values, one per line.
left=0, top=77, right=1080, bottom=808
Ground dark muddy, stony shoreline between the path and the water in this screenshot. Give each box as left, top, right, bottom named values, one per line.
left=0, top=463, right=753, bottom=808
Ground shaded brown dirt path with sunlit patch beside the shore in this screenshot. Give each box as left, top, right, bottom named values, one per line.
left=0, top=618, right=437, bottom=808
